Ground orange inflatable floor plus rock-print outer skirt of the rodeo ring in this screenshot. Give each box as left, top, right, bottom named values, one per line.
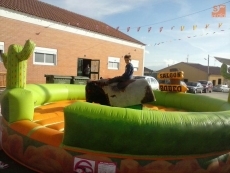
left=2, top=101, right=230, bottom=173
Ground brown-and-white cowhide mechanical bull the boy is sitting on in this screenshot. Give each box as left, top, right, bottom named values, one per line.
left=86, top=79, right=155, bottom=107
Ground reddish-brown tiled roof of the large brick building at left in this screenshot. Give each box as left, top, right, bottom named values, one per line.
left=0, top=0, right=145, bottom=45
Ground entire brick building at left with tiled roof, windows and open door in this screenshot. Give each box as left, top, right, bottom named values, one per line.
left=0, top=0, right=145, bottom=83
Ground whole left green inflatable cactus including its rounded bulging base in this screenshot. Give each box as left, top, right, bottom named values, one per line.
left=0, top=40, right=35, bottom=123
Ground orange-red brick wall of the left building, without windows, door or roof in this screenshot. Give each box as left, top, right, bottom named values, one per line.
left=0, top=17, right=143, bottom=83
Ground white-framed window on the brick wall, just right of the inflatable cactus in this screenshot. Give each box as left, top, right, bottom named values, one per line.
left=33, top=47, right=57, bottom=65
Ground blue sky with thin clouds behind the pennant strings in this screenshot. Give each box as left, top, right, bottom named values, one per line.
left=41, top=0, right=230, bottom=70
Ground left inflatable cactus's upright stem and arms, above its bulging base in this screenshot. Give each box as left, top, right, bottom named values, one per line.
left=2, top=40, right=35, bottom=89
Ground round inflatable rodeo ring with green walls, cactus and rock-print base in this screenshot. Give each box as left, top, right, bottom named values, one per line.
left=1, top=40, right=230, bottom=173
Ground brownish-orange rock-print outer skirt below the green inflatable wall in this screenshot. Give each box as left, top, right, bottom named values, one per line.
left=2, top=119, right=230, bottom=173
